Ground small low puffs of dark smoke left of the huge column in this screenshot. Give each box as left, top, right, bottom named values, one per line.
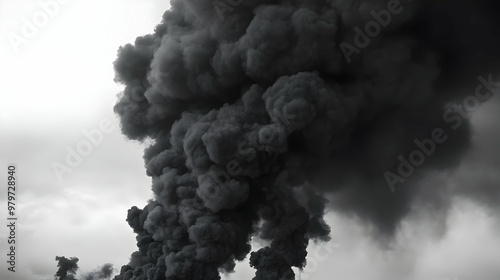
left=55, top=256, right=113, bottom=280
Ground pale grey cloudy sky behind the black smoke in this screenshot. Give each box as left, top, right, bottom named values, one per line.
left=0, top=0, right=500, bottom=280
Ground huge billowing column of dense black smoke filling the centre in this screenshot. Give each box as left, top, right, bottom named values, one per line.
left=114, top=0, right=498, bottom=280
